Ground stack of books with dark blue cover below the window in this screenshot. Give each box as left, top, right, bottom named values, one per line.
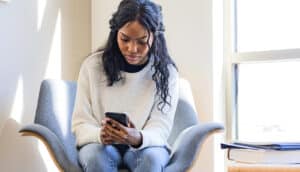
left=221, top=142, right=300, bottom=164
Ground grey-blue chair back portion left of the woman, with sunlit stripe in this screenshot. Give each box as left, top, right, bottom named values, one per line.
left=34, top=80, right=78, bottom=164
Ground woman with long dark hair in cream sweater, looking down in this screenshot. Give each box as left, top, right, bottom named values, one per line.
left=72, top=0, right=178, bottom=172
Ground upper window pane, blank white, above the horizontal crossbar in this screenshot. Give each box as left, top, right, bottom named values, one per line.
left=236, top=0, right=300, bottom=52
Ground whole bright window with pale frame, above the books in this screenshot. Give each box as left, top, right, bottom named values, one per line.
left=224, top=0, right=300, bottom=142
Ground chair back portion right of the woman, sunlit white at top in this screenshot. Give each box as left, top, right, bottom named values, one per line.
left=168, top=78, right=198, bottom=146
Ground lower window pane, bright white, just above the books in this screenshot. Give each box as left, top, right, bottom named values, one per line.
left=237, top=61, right=300, bottom=141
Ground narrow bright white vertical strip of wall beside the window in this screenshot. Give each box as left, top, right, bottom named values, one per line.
left=212, top=0, right=225, bottom=172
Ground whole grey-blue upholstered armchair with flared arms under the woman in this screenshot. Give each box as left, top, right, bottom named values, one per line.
left=19, top=80, right=223, bottom=172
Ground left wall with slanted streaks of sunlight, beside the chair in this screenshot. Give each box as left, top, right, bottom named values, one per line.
left=0, top=0, right=91, bottom=172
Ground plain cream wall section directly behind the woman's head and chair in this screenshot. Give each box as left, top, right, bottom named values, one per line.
left=92, top=0, right=220, bottom=172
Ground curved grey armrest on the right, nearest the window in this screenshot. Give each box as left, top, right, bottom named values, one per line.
left=166, top=122, right=224, bottom=172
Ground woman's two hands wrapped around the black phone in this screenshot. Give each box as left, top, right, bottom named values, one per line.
left=100, top=118, right=142, bottom=147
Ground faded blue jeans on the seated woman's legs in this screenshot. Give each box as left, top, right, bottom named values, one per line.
left=79, top=143, right=169, bottom=172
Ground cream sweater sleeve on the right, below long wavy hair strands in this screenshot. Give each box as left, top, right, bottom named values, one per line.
left=138, top=68, right=179, bottom=149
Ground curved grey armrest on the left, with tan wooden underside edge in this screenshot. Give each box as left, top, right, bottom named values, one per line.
left=19, top=124, right=82, bottom=172
